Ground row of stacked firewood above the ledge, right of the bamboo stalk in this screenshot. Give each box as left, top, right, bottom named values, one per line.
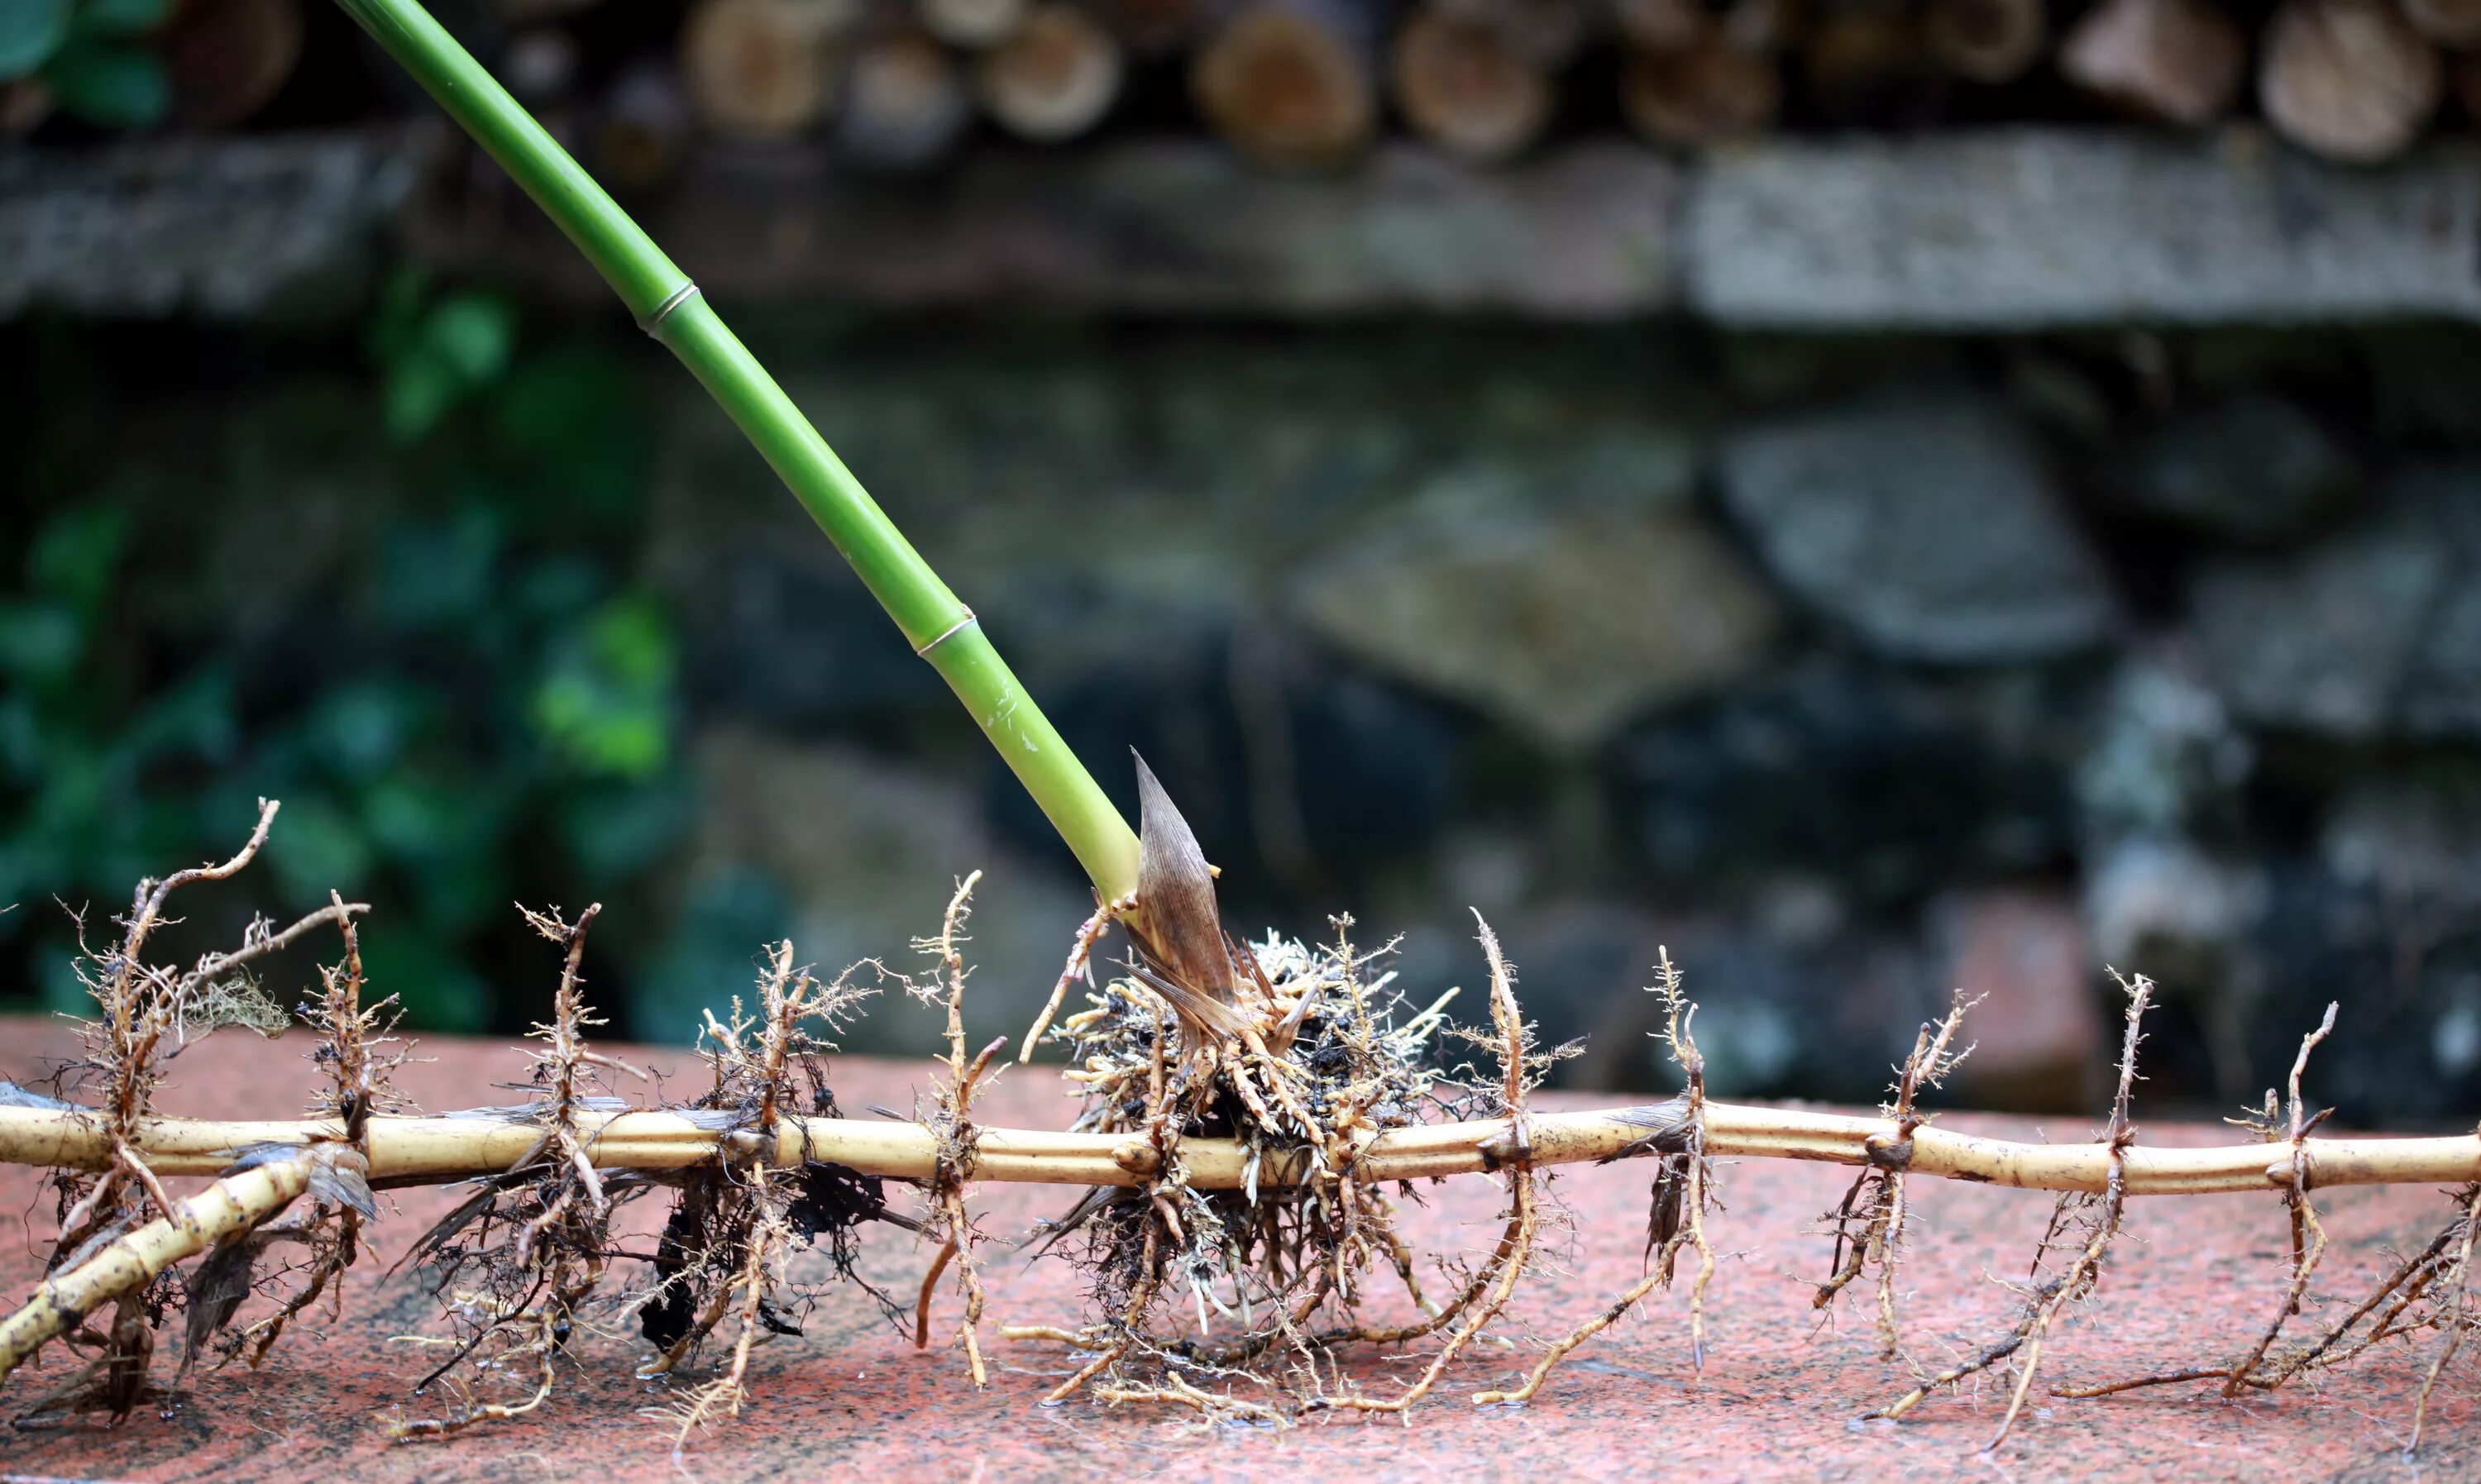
left=618, top=0, right=2481, bottom=166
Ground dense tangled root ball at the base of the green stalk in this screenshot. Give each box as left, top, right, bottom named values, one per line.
left=1002, top=919, right=1628, bottom=1420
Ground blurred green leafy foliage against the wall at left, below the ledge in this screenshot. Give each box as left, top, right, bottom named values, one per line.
left=0, top=278, right=690, bottom=1033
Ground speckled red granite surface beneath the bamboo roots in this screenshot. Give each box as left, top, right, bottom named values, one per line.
left=0, top=1020, right=2481, bottom=1484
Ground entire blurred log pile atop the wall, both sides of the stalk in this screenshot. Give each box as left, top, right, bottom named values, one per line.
left=0, top=0, right=2481, bottom=169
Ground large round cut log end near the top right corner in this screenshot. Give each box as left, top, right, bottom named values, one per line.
left=2258, top=0, right=2446, bottom=164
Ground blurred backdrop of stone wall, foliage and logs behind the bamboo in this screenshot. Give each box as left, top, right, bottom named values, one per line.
left=0, top=0, right=2481, bottom=1127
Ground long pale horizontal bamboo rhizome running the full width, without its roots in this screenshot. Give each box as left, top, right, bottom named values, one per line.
left=0, top=1100, right=2481, bottom=1196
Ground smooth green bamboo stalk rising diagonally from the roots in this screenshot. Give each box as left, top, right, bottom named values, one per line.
left=337, top=0, right=1136, bottom=901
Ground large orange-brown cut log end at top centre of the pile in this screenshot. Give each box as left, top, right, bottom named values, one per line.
left=1191, top=0, right=1377, bottom=166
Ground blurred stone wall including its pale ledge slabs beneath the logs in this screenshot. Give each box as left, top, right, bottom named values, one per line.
left=14, top=126, right=2481, bottom=1119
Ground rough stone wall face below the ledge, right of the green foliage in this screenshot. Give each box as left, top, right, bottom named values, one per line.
left=645, top=320, right=2481, bottom=1119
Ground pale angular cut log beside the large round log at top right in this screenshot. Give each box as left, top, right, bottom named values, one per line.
left=2059, top=0, right=2248, bottom=129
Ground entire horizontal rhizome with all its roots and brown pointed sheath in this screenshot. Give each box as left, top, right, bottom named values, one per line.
left=0, top=799, right=2481, bottom=1447
